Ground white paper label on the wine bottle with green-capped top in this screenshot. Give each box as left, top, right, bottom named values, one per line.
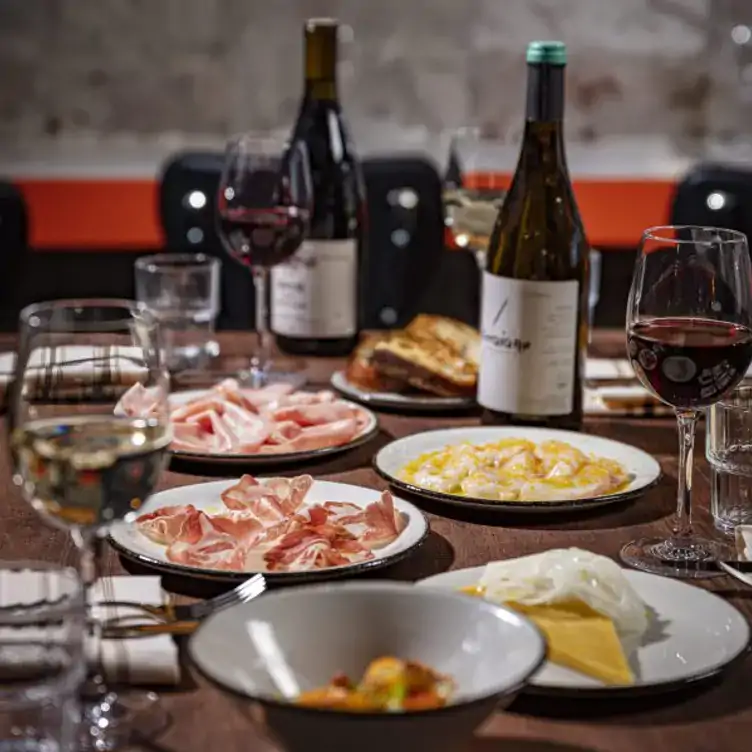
left=478, top=272, right=580, bottom=416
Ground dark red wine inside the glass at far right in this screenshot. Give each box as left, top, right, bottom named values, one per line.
left=627, top=317, right=752, bottom=409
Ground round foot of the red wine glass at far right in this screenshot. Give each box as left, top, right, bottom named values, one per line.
left=620, top=536, right=726, bottom=579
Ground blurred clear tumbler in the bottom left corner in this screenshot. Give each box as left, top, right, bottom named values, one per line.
left=0, top=561, right=86, bottom=752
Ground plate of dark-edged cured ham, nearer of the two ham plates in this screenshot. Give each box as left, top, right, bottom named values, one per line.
left=110, top=475, right=428, bottom=582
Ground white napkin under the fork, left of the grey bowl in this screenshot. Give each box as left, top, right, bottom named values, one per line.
left=87, top=575, right=180, bottom=685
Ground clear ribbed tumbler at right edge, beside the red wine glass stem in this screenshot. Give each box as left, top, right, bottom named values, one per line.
left=705, top=386, right=752, bottom=535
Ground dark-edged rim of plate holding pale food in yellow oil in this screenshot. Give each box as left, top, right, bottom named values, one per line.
left=371, top=426, right=663, bottom=514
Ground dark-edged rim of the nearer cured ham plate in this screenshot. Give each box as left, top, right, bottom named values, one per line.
left=107, top=478, right=431, bottom=584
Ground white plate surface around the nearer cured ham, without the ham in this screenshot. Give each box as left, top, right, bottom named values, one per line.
left=110, top=480, right=428, bottom=582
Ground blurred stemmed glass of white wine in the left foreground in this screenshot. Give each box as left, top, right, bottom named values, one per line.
left=8, top=300, right=171, bottom=749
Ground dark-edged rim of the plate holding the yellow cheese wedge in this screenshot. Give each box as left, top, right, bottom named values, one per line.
left=415, top=557, right=752, bottom=701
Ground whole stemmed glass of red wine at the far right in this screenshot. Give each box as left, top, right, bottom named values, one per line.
left=621, top=226, right=752, bottom=577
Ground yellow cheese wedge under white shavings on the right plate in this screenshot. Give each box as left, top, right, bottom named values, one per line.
left=462, top=586, right=634, bottom=685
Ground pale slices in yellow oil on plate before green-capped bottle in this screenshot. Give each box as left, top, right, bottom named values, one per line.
left=399, top=438, right=629, bottom=501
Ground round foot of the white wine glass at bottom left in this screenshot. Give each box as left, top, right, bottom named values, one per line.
left=79, top=691, right=162, bottom=752
